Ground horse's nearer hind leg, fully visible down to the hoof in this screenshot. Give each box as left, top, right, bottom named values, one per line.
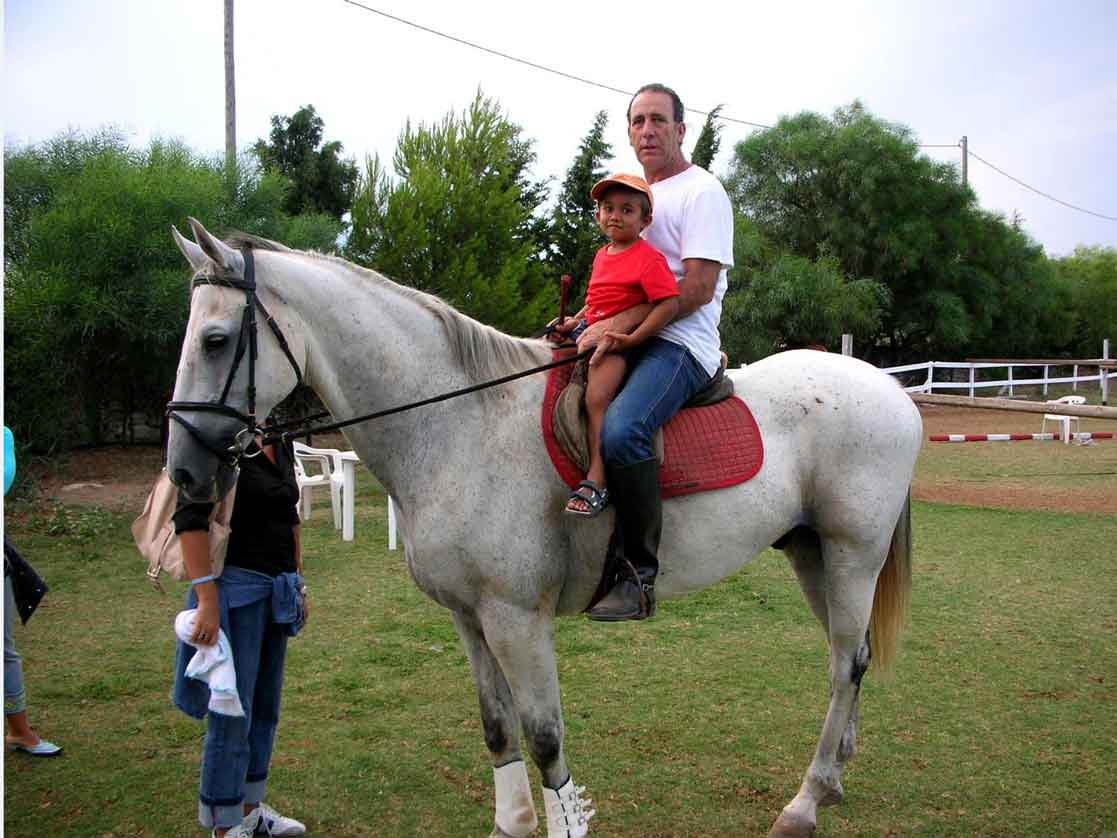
left=768, top=539, right=887, bottom=838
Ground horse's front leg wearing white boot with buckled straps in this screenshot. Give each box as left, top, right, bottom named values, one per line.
left=479, top=602, right=594, bottom=838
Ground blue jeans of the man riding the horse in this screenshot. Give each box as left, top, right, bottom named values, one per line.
left=601, top=337, right=709, bottom=466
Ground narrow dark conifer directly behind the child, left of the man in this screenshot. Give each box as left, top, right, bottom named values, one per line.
left=548, top=111, right=613, bottom=303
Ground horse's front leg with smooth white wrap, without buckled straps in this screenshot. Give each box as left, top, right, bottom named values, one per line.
left=454, top=612, right=538, bottom=838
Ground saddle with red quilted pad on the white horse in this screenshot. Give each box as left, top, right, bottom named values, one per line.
left=542, top=351, right=764, bottom=498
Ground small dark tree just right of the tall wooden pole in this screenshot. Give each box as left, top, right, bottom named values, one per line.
left=252, top=105, right=357, bottom=220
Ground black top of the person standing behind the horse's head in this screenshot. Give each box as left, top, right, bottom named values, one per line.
left=174, top=444, right=298, bottom=577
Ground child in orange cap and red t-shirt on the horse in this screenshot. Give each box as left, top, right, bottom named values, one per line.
left=556, top=174, right=679, bottom=517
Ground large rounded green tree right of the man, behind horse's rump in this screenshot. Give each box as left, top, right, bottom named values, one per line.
left=727, top=102, right=1002, bottom=356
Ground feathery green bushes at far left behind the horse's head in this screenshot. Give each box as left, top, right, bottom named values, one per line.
left=4, top=131, right=340, bottom=450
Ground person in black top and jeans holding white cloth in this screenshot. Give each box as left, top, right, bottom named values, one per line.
left=174, top=440, right=307, bottom=838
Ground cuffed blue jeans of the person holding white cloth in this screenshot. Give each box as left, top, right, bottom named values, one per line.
left=198, top=599, right=287, bottom=828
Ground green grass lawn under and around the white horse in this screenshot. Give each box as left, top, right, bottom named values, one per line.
left=4, top=469, right=1117, bottom=838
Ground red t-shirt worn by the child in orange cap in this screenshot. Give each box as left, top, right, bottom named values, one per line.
left=585, top=239, right=679, bottom=323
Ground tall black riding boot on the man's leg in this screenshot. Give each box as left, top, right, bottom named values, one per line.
left=589, top=458, right=663, bottom=622
